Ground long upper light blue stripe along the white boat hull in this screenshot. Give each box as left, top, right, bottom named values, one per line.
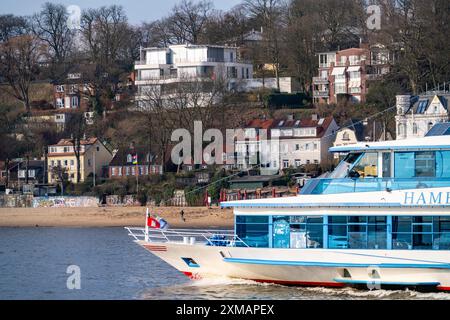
left=223, top=258, right=450, bottom=269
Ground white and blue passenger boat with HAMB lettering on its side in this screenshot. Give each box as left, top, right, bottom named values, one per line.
left=128, top=136, right=450, bottom=290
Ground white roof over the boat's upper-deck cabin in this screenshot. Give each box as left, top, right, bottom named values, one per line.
left=330, top=136, right=450, bottom=152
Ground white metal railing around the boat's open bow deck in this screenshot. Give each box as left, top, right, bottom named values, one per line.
left=125, top=227, right=249, bottom=247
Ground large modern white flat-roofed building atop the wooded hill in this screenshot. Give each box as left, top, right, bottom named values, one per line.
left=135, top=44, right=253, bottom=108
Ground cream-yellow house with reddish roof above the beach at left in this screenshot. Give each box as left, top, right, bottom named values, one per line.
left=47, top=138, right=113, bottom=183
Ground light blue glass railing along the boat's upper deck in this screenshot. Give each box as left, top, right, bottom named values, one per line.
left=301, top=178, right=450, bottom=194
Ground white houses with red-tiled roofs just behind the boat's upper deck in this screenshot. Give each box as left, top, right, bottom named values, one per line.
left=235, top=115, right=339, bottom=171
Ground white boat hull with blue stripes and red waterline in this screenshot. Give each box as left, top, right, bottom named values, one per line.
left=137, top=241, right=450, bottom=290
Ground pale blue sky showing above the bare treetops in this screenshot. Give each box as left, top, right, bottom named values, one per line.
left=0, top=0, right=242, bottom=24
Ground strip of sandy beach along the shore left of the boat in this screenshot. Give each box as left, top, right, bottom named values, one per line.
left=0, top=207, right=233, bottom=229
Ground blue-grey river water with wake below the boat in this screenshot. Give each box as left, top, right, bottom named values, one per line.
left=0, top=228, right=450, bottom=300
